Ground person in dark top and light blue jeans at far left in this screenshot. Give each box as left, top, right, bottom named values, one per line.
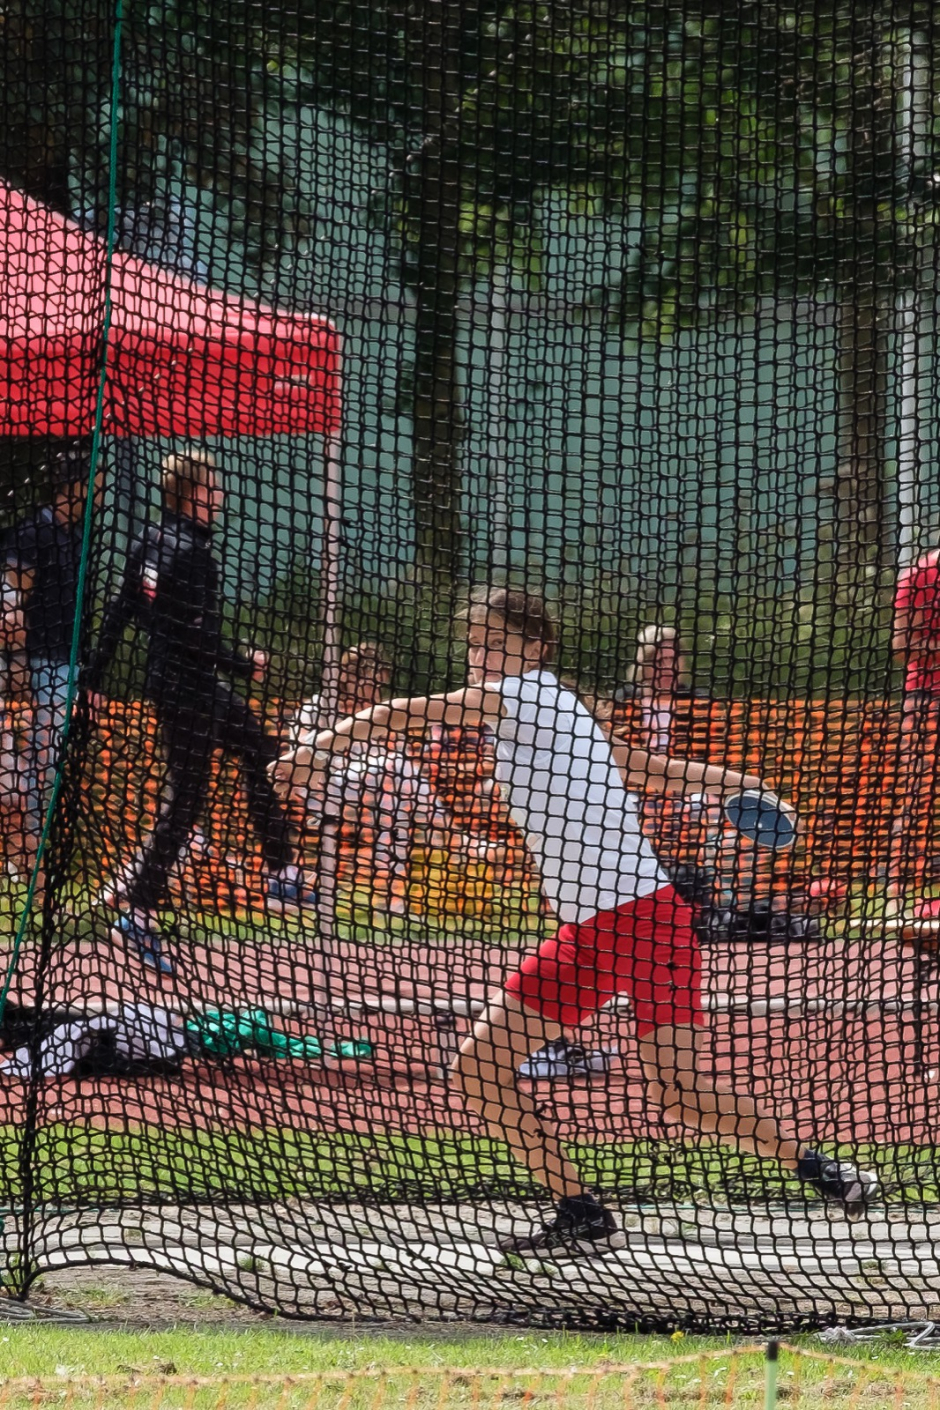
left=3, top=443, right=99, bottom=891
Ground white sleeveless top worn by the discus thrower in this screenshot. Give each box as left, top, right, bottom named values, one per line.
left=486, top=671, right=669, bottom=924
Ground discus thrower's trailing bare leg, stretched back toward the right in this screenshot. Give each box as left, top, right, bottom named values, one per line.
left=640, top=1025, right=806, bottom=1170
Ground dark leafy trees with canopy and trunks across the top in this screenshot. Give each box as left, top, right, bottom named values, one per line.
left=0, top=0, right=940, bottom=578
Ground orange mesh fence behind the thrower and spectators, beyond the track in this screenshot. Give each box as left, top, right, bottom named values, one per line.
left=42, top=698, right=939, bottom=917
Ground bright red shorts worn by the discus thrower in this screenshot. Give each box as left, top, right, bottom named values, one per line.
left=506, top=885, right=703, bottom=1038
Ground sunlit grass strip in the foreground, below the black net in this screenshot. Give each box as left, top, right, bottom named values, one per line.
left=0, top=1327, right=940, bottom=1410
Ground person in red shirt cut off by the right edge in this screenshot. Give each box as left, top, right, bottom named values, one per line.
left=886, top=548, right=940, bottom=919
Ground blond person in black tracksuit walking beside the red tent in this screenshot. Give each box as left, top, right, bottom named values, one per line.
left=85, top=450, right=316, bottom=974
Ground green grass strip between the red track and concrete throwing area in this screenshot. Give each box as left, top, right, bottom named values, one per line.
left=0, top=1122, right=940, bottom=1207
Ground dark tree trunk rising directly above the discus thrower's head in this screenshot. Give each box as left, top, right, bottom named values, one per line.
left=404, top=0, right=468, bottom=584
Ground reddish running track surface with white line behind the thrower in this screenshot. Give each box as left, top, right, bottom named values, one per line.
left=0, top=936, right=940, bottom=1145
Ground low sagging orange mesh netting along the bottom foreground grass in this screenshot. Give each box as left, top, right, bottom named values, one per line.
left=0, top=1345, right=940, bottom=1410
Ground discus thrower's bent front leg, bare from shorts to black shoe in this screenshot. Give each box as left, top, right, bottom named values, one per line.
left=452, top=994, right=585, bottom=1200
